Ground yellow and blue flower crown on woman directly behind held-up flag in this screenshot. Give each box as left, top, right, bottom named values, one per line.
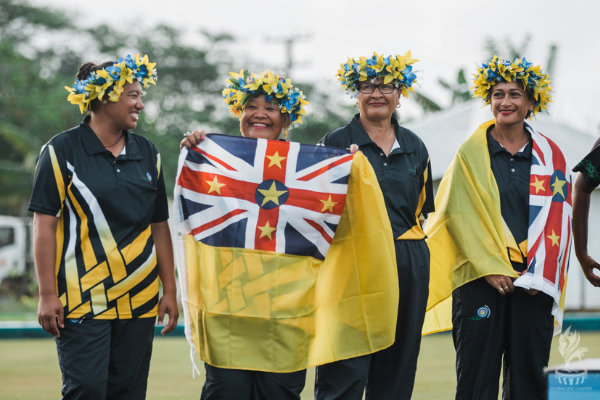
left=223, top=69, right=310, bottom=125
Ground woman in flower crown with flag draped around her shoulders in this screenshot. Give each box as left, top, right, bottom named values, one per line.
left=424, top=56, right=572, bottom=400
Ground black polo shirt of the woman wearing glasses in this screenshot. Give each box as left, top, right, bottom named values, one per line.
left=319, top=114, right=434, bottom=240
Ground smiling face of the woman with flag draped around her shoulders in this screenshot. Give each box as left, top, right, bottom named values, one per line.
left=490, top=81, right=534, bottom=125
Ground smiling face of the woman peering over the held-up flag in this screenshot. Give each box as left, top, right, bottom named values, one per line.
left=240, top=94, right=283, bottom=140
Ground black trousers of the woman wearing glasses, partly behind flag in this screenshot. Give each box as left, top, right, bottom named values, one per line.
left=315, top=240, right=429, bottom=400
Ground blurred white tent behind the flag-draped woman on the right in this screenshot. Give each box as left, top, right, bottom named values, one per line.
left=403, top=100, right=600, bottom=310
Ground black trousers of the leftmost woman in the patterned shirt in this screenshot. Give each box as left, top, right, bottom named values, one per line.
left=56, top=318, right=155, bottom=400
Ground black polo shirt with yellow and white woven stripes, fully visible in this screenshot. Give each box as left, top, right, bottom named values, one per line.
left=29, top=117, right=168, bottom=319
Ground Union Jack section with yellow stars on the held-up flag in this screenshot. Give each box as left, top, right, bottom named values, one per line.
left=178, top=134, right=353, bottom=260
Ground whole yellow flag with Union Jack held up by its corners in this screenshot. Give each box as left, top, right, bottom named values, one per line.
left=175, top=134, right=398, bottom=372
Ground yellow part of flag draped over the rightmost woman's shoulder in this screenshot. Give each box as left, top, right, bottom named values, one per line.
left=423, top=120, right=518, bottom=335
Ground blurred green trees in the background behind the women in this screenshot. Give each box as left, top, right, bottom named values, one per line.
left=0, top=0, right=556, bottom=216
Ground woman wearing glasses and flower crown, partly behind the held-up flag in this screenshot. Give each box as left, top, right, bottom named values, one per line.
left=315, top=51, right=433, bottom=400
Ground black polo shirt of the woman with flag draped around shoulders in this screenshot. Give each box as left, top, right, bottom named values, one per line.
left=487, top=124, right=533, bottom=271
